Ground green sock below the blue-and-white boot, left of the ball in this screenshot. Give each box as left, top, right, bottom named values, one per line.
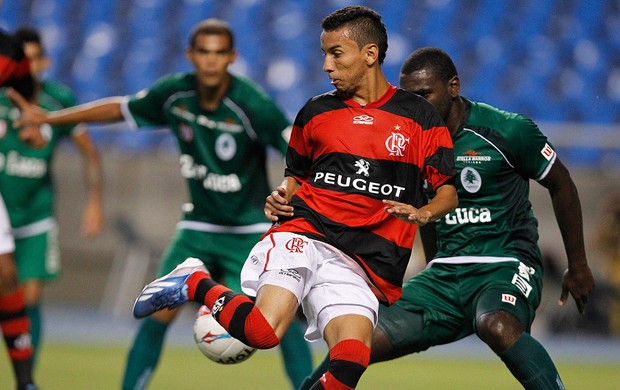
left=123, top=318, right=168, bottom=390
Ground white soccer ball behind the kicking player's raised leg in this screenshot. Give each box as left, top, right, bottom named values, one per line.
left=194, top=305, right=256, bottom=364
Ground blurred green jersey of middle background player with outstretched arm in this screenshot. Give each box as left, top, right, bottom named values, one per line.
left=123, top=73, right=290, bottom=229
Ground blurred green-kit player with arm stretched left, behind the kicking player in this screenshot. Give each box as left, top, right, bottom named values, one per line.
left=7, top=19, right=312, bottom=389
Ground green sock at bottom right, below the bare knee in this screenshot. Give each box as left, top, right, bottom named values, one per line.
left=499, top=333, right=564, bottom=390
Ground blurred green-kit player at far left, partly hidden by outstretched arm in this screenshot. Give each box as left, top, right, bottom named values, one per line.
left=0, top=28, right=103, bottom=364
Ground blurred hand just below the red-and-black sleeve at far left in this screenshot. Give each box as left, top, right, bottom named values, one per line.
left=7, top=88, right=47, bottom=148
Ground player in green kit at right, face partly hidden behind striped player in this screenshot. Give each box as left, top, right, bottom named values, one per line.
left=298, top=48, right=594, bottom=389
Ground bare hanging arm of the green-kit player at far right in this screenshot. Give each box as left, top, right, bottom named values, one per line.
left=540, top=158, right=594, bottom=313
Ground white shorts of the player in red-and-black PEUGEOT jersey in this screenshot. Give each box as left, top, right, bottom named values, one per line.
left=241, top=232, right=379, bottom=341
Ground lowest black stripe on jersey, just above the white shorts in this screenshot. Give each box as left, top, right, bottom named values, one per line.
left=291, top=200, right=411, bottom=286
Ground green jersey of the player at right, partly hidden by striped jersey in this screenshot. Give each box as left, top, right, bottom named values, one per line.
left=435, top=101, right=556, bottom=267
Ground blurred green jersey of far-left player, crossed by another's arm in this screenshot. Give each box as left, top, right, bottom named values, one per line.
left=0, top=82, right=77, bottom=229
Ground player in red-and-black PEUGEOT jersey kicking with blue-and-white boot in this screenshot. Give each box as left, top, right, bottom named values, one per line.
left=134, top=6, right=458, bottom=389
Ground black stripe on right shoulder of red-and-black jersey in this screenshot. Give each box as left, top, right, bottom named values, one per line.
left=379, top=88, right=444, bottom=130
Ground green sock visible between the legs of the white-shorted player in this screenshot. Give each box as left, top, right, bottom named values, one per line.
left=280, top=320, right=312, bottom=389
